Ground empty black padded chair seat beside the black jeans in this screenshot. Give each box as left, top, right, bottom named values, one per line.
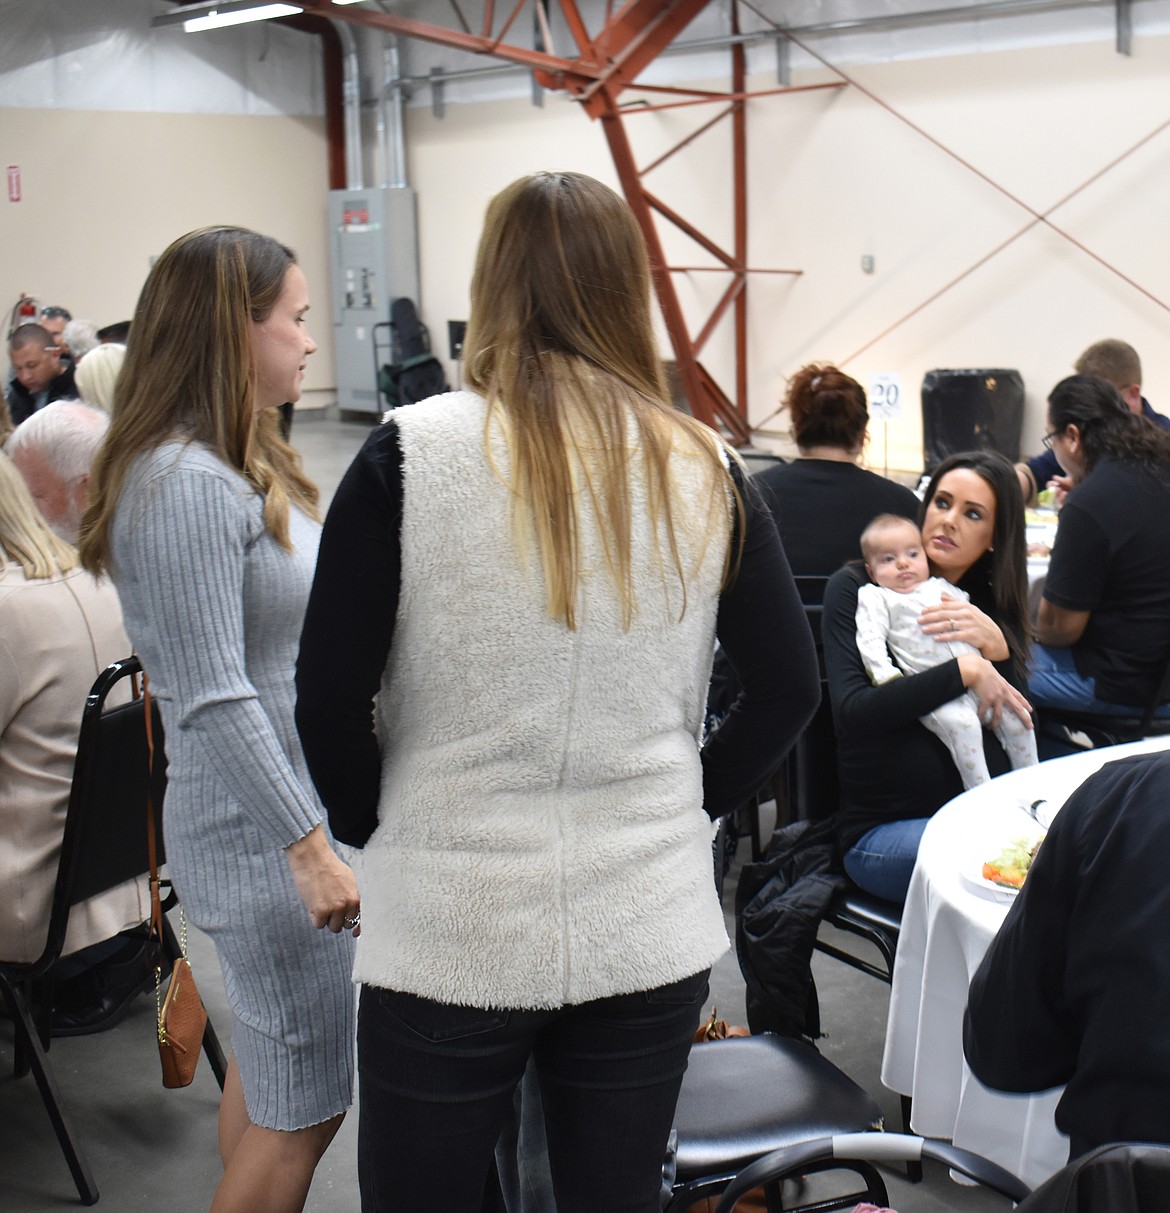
left=674, top=1033, right=881, bottom=1183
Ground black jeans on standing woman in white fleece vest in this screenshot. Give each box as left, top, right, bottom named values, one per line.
left=358, top=969, right=710, bottom=1213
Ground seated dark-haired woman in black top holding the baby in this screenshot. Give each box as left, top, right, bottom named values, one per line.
left=822, top=451, right=1031, bottom=901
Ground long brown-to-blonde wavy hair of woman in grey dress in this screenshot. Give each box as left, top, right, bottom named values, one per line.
left=81, top=227, right=318, bottom=573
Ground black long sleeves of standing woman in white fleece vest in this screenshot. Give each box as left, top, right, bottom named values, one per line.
left=296, top=422, right=820, bottom=847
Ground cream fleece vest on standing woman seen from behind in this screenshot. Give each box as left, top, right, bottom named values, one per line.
left=354, top=392, right=727, bottom=1008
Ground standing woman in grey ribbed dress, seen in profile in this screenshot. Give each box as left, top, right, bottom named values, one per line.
left=82, top=228, right=359, bottom=1213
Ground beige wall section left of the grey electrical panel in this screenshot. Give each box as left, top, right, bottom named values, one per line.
left=0, top=109, right=333, bottom=392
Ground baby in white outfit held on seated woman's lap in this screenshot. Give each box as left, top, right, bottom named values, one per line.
left=857, top=514, right=1037, bottom=787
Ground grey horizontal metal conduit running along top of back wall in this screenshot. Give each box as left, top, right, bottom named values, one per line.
left=380, top=0, right=1117, bottom=89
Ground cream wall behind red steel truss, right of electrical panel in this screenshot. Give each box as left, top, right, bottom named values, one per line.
left=407, top=38, right=1170, bottom=469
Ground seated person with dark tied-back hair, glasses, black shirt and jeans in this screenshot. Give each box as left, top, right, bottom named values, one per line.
left=1028, top=375, right=1170, bottom=716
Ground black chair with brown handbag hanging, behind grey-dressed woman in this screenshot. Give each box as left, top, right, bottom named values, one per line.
left=0, top=657, right=227, bottom=1205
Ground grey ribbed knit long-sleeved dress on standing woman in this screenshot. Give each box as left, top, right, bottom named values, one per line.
left=110, top=442, right=354, bottom=1129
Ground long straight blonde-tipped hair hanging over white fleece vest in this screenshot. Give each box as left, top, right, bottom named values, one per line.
left=466, top=172, right=743, bottom=628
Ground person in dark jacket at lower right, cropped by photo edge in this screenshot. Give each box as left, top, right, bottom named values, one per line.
left=963, top=747, right=1170, bottom=1158
